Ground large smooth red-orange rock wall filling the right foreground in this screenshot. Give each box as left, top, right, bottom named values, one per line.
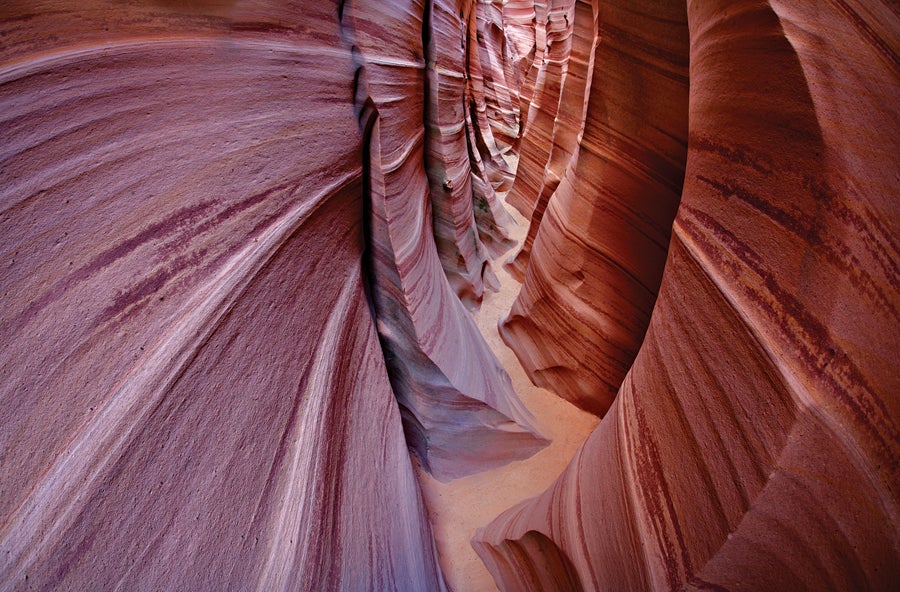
left=474, top=0, right=900, bottom=590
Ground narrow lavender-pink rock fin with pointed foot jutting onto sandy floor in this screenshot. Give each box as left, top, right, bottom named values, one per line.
left=344, top=2, right=547, bottom=480
